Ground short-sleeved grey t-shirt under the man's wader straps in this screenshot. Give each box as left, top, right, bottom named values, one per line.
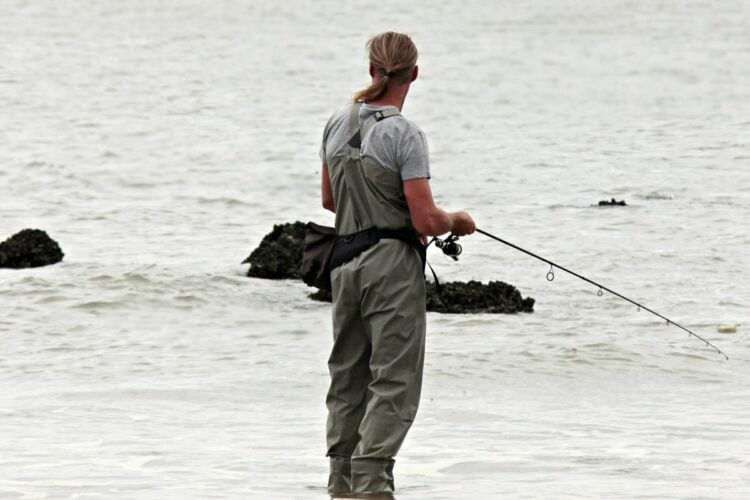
left=320, top=104, right=430, bottom=180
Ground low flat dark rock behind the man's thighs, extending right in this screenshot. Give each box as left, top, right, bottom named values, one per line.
left=310, top=281, right=534, bottom=314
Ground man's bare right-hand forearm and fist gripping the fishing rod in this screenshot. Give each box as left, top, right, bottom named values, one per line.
left=404, top=178, right=476, bottom=236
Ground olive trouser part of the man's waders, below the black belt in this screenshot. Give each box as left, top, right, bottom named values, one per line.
left=326, top=240, right=426, bottom=494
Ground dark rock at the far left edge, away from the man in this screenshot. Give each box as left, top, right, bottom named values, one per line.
left=0, top=229, right=65, bottom=269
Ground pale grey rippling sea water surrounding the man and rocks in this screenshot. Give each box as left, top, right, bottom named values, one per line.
left=0, top=0, right=750, bottom=500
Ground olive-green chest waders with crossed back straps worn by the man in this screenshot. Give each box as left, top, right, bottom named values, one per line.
left=326, top=104, right=426, bottom=495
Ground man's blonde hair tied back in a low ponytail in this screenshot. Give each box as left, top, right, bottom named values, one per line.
left=354, top=31, right=417, bottom=102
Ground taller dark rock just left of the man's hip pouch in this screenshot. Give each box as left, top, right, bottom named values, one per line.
left=242, top=221, right=307, bottom=279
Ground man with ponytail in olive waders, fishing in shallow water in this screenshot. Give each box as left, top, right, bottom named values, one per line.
left=320, top=32, right=475, bottom=498
